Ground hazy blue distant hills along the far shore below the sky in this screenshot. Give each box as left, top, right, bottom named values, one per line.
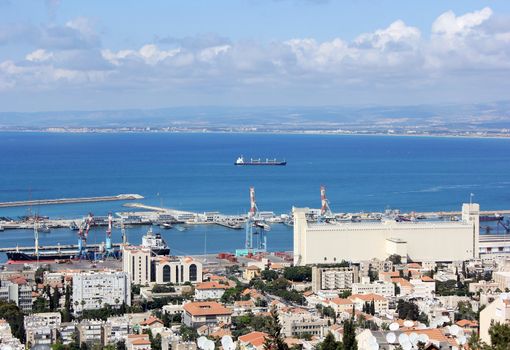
left=0, top=101, right=510, bottom=130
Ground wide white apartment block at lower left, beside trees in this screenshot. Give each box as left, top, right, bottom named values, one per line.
left=73, top=271, right=131, bottom=314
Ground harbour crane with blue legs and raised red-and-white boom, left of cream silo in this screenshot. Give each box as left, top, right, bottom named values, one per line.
left=245, top=187, right=271, bottom=253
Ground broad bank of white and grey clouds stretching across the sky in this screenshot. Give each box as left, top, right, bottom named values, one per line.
left=0, top=8, right=510, bottom=102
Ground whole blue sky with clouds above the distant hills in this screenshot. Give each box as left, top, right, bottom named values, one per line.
left=0, top=0, right=510, bottom=112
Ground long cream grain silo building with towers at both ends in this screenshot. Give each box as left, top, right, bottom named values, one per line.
left=293, top=203, right=480, bottom=265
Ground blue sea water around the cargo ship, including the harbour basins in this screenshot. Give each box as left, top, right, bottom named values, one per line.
left=0, top=133, right=510, bottom=262
